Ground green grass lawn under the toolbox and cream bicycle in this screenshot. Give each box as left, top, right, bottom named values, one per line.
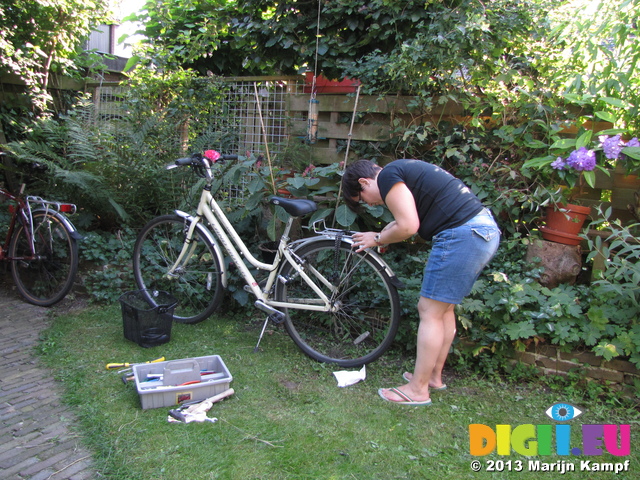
left=40, top=305, right=640, bottom=480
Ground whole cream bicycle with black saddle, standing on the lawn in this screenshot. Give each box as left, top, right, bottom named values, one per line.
left=133, top=151, right=401, bottom=367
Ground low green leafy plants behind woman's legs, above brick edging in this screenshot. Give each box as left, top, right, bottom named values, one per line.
left=458, top=232, right=640, bottom=372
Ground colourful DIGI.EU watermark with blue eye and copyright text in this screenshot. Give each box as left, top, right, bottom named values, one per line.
left=469, top=403, right=631, bottom=473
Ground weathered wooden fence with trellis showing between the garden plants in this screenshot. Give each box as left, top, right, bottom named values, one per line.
left=2, top=76, right=640, bottom=221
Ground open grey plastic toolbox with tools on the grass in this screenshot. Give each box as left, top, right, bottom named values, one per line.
left=133, top=355, right=233, bottom=409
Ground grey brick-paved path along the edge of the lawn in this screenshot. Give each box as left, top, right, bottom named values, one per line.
left=0, top=282, right=99, bottom=480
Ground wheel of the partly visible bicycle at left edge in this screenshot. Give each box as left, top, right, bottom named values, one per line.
left=9, top=212, right=79, bottom=307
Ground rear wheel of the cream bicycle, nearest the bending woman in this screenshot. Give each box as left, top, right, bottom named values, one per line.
left=274, top=239, right=400, bottom=367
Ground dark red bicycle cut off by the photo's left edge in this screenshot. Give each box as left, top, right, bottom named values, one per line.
left=0, top=185, right=81, bottom=307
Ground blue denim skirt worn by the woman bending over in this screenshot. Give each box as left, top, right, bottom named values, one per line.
left=420, top=208, right=500, bottom=304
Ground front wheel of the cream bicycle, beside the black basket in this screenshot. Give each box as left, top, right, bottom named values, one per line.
left=133, top=215, right=224, bottom=324
